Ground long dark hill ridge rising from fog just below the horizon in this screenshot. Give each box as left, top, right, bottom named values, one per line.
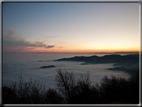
left=54, top=54, right=139, bottom=64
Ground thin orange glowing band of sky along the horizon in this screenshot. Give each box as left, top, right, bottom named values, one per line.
left=3, top=47, right=139, bottom=53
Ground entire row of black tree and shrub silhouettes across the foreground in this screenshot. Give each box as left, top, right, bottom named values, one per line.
left=2, top=69, right=139, bottom=104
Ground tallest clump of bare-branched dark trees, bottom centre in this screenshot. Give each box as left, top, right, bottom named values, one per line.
left=56, top=69, right=96, bottom=103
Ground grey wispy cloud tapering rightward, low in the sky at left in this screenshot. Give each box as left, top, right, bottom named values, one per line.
left=3, top=30, right=55, bottom=50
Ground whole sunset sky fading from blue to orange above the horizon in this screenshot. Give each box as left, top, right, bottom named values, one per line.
left=3, top=3, right=140, bottom=52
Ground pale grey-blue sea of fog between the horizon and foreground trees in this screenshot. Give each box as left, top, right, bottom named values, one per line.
left=2, top=53, right=130, bottom=88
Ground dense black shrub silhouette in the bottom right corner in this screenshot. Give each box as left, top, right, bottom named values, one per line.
left=98, top=76, right=139, bottom=104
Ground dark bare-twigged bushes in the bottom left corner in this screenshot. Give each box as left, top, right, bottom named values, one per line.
left=2, top=74, right=45, bottom=104
